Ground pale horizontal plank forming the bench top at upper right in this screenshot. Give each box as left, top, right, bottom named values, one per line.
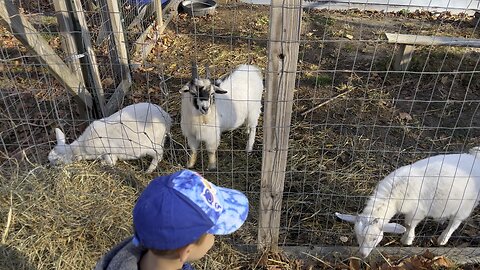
left=385, top=33, right=480, bottom=48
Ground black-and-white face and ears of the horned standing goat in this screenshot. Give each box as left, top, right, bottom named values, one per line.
left=180, top=79, right=227, bottom=114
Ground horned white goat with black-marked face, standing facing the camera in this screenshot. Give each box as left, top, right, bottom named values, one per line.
left=180, top=65, right=263, bottom=169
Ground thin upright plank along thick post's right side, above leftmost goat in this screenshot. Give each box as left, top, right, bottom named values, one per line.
left=71, top=0, right=106, bottom=117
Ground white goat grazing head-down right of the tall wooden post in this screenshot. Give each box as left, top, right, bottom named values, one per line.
left=335, top=147, right=480, bottom=257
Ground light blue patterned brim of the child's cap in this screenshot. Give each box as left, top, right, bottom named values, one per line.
left=207, top=186, right=248, bottom=235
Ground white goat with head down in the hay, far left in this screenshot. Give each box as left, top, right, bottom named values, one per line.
left=48, top=103, right=172, bottom=173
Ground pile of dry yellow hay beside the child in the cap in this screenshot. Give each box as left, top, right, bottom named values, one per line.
left=0, top=155, right=266, bottom=270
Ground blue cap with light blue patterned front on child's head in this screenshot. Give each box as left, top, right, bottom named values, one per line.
left=133, top=170, right=248, bottom=250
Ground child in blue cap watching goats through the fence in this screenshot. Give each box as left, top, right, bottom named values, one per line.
left=95, top=170, right=248, bottom=270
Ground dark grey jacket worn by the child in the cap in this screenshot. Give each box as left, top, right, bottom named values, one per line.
left=95, top=237, right=194, bottom=270
